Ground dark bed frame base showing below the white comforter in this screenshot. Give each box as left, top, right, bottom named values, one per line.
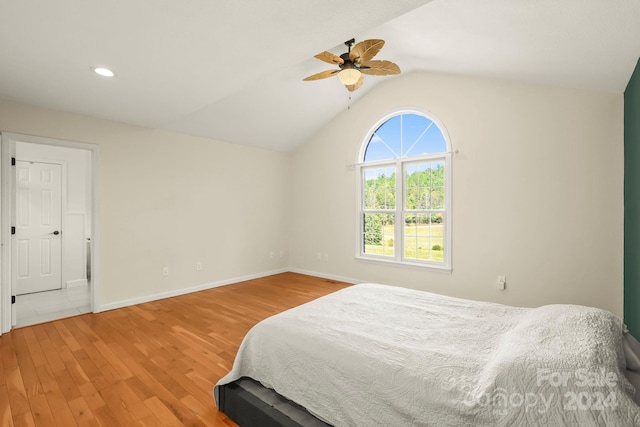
left=218, top=378, right=331, bottom=427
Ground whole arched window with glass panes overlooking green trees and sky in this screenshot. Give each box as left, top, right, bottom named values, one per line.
left=357, top=111, right=451, bottom=269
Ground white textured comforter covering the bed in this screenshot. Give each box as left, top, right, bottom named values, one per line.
left=216, top=284, right=640, bottom=427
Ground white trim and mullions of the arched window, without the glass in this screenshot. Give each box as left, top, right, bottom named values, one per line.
left=355, top=111, right=453, bottom=272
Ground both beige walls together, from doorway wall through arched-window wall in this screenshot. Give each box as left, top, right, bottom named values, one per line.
left=0, top=68, right=623, bottom=315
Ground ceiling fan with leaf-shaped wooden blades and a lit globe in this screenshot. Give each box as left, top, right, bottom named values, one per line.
left=303, top=39, right=400, bottom=92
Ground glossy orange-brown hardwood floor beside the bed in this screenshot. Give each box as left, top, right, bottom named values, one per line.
left=0, top=273, right=348, bottom=427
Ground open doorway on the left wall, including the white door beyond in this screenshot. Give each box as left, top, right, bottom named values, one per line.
left=0, top=133, right=98, bottom=332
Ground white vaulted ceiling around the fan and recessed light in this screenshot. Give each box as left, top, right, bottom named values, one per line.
left=0, top=0, right=640, bottom=151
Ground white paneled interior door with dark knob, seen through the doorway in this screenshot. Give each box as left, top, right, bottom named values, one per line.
left=12, top=160, right=62, bottom=295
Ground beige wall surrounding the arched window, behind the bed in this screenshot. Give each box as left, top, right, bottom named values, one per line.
left=290, top=73, right=623, bottom=315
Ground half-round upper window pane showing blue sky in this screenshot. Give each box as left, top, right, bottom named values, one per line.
left=362, top=112, right=450, bottom=163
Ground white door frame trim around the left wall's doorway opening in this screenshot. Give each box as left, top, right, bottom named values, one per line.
left=0, top=132, right=100, bottom=335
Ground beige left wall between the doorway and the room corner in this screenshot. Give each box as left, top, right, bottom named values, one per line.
left=0, top=101, right=289, bottom=307
